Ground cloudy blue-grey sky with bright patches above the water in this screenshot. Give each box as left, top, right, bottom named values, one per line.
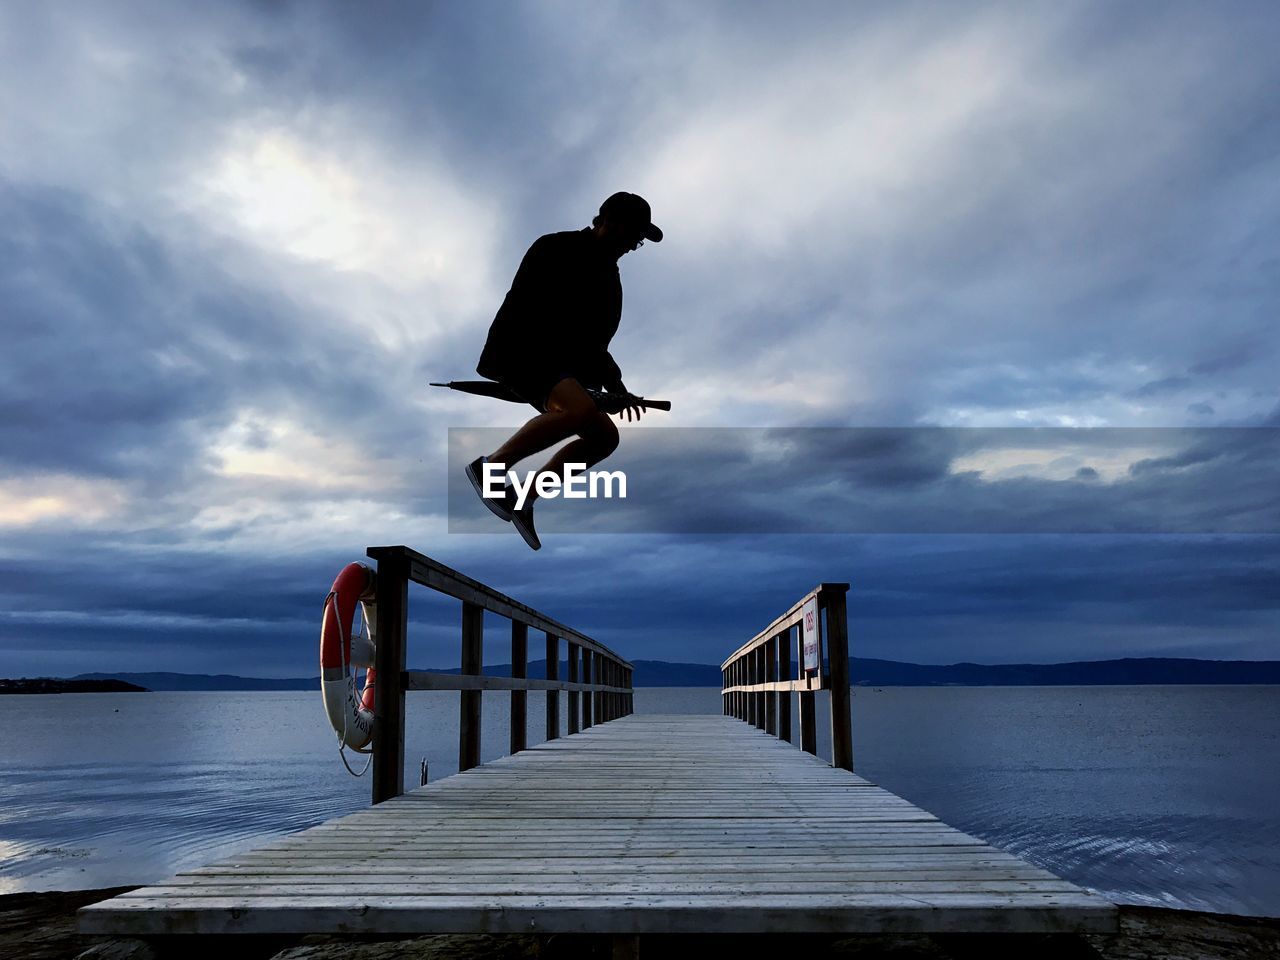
left=0, top=0, right=1280, bottom=676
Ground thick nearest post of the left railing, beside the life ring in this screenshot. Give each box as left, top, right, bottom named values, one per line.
left=371, top=554, right=408, bottom=804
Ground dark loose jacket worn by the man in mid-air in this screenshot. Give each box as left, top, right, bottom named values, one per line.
left=476, top=228, right=622, bottom=387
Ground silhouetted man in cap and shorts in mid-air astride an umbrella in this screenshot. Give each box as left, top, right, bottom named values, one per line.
left=466, top=193, right=662, bottom=550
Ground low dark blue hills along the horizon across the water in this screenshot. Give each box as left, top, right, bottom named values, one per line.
left=73, top=657, right=1280, bottom=690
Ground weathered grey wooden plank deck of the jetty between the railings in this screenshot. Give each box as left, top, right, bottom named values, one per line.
left=79, top=716, right=1116, bottom=936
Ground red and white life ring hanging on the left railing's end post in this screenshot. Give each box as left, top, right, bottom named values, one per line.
left=320, top=563, right=378, bottom=753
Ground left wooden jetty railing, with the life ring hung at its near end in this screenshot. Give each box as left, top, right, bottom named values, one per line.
left=366, top=547, right=635, bottom=804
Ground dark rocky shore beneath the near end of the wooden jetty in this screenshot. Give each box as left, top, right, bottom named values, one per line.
left=0, top=887, right=1280, bottom=960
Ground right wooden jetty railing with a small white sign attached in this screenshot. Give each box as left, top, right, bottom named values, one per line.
left=721, top=584, right=854, bottom=771
